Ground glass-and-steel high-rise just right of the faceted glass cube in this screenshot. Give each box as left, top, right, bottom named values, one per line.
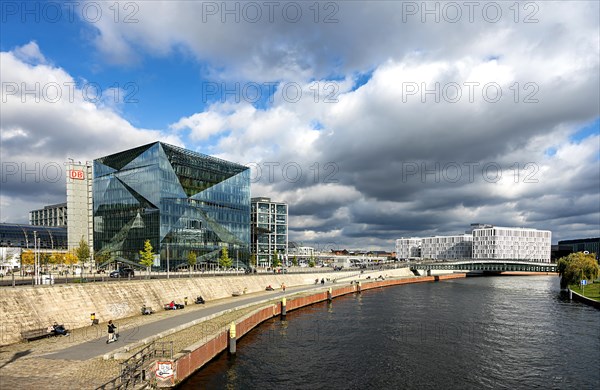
left=251, top=197, right=288, bottom=266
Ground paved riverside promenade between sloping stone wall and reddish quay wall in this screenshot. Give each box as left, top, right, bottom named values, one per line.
left=0, top=277, right=464, bottom=389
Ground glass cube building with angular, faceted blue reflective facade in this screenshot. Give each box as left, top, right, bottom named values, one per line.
left=93, top=142, right=250, bottom=269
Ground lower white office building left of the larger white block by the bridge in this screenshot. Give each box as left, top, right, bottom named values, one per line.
left=421, top=234, right=473, bottom=260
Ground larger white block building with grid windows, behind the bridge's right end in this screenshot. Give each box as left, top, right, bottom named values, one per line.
left=473, top=226, right=552, bottom=263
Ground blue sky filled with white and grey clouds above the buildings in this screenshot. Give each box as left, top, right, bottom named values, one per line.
left=0, top=1, right=600, bottom=250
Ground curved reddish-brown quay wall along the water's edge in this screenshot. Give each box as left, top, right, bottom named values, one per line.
left=169, top=274, right=466, bottom=387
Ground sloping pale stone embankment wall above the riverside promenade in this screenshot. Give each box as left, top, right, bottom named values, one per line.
left=0, top=268, right=411, bottom=345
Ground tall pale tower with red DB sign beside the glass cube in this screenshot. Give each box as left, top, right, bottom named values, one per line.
left=66, top=161, right=94, bottom=256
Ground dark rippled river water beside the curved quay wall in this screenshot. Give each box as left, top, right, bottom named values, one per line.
left=181, top=276, right=600, bottom=390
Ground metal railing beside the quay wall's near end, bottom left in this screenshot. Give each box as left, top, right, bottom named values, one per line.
left=96, top=341, right=173, bottom=390
